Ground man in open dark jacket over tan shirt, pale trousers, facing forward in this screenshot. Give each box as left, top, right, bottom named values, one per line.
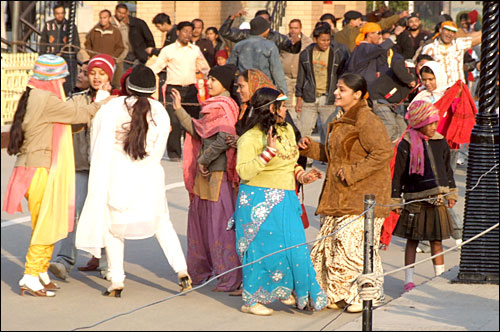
left=295, top=22, right=349, bottom=144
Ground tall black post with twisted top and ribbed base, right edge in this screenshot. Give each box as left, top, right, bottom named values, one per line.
left=455, top=1, right=500, bottom=284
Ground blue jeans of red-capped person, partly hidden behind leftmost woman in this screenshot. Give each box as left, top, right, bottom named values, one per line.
left=55, top=171, right=108, bottom=273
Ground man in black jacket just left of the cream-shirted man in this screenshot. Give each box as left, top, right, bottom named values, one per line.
left=115, top=4, right=155, bottom=71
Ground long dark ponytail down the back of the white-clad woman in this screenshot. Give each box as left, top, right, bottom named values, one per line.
left=122, top=92, right=151, bottom=160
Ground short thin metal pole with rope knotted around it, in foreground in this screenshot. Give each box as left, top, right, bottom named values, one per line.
left=363, top=194, right=375, bottom=331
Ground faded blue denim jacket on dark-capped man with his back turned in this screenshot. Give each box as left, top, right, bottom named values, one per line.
left=227, top=36, right=288, bottom=94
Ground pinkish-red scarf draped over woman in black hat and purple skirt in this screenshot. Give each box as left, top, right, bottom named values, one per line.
left=182, top=96, right=239, bottom=195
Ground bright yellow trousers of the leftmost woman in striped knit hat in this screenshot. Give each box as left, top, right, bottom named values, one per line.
left=24, top=168, right=54, bottom=277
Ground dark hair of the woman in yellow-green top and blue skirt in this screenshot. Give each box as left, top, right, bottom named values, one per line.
left=239, top=88, right=284, bottom=135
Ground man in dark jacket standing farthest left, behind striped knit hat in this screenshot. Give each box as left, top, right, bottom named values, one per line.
left=40, top=4, right=80, bottom=94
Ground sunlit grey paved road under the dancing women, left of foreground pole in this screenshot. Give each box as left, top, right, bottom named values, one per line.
left=1, top=150, right=468, bottom=330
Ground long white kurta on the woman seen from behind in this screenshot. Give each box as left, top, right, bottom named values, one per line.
left=76, top=97, right=170, bottom=258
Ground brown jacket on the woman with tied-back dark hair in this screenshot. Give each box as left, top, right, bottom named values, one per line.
left=301, top=100, right=393, bottom=218
